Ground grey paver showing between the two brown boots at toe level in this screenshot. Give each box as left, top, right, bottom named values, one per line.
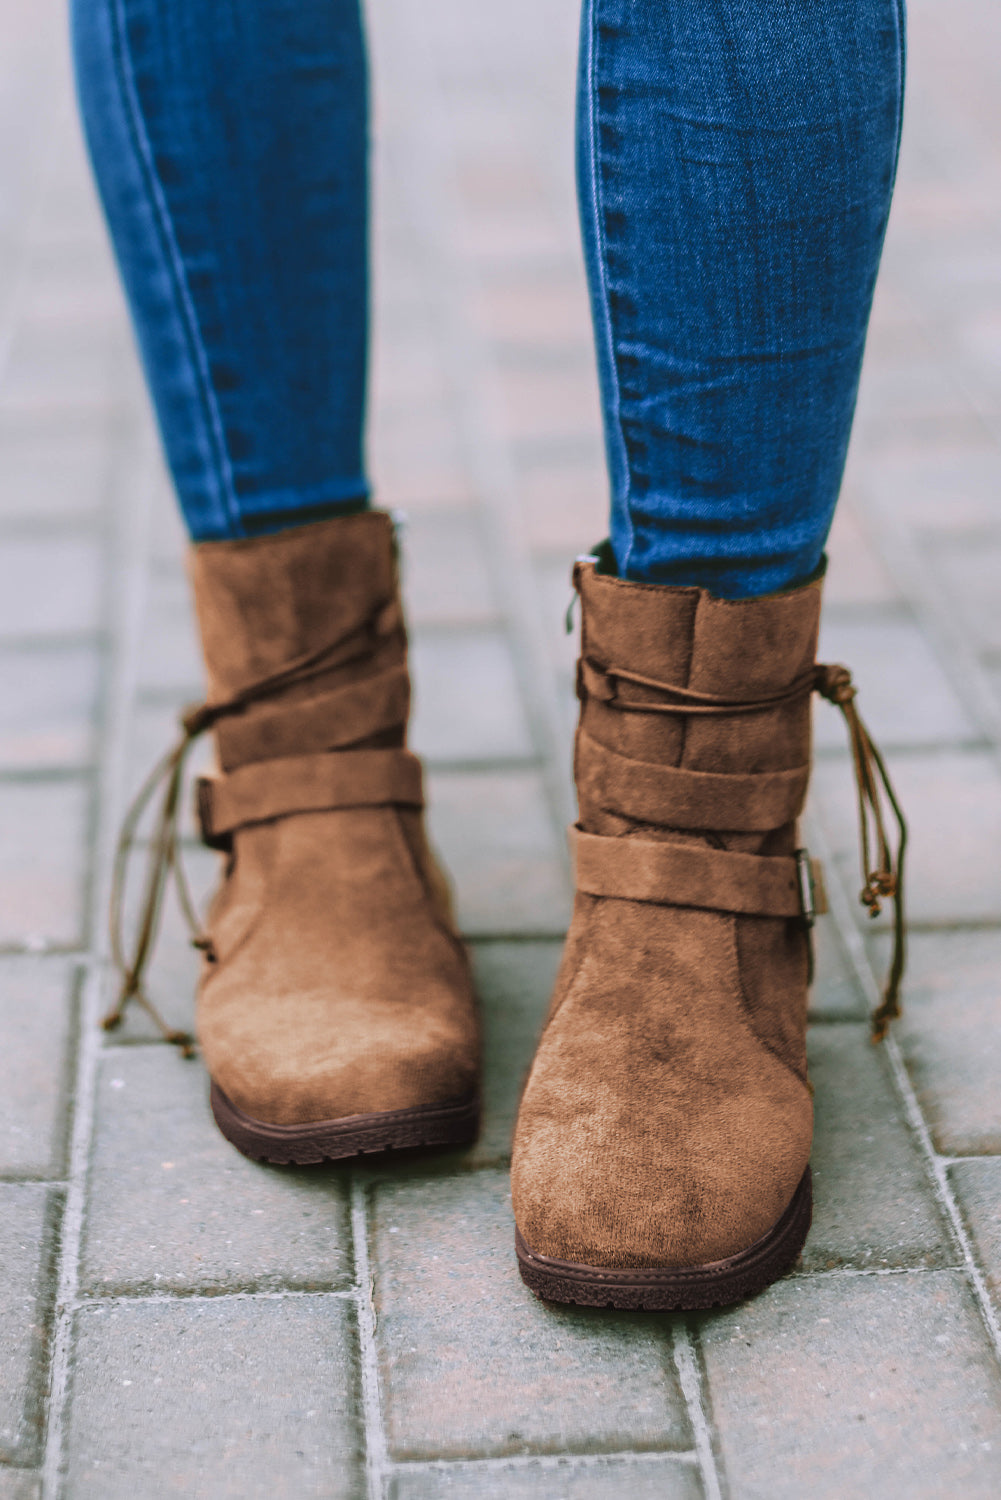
left=465, top=942, right=563, bottom=1164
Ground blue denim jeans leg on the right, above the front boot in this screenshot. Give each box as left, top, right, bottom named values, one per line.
left=578, top=0, right=903, bottom=597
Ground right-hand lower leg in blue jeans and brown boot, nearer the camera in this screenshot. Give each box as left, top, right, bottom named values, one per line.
left=512, top=0, right=902, bottom=1308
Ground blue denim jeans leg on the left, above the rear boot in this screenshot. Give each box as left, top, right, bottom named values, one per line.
left=72, top=0, right=368, bottom=539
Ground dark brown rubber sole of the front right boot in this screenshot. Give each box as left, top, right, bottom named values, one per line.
left=515, top=1167, right=813, bottom=1313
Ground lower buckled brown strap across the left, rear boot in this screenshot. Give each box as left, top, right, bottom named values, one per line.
left=197, top=750, right=423, bottom=846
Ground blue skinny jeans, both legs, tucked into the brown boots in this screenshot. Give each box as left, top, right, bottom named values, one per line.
left=72, top=0, right=903, bottom=599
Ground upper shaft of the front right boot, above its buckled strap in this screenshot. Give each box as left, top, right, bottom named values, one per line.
left=575, top=561, right=821, bottom=852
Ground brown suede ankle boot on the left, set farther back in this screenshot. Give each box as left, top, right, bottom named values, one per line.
left=113, top=512, right=479, bottom=1163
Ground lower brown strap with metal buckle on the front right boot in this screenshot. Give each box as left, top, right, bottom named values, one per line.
left=570, top=827, right=827, bottom=926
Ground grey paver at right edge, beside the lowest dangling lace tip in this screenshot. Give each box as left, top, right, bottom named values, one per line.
left=875, top=929, right=1001, bottom=1157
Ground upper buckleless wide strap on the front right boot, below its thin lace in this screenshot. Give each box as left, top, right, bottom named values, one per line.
left=576, top=729, right=810, bottom=834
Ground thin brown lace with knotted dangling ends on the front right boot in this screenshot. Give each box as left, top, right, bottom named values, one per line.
left=578, top=657, right=906, bottom=1043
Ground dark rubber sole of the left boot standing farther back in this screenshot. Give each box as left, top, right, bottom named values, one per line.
left=210, top=1083, right=480, bottom=1167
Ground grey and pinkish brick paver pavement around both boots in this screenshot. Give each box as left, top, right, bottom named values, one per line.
left=0, top=0, right=1001, bottom=1500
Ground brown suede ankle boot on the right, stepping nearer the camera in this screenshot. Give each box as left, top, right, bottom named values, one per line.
left=512, top=558, right=902, bottom=1308
